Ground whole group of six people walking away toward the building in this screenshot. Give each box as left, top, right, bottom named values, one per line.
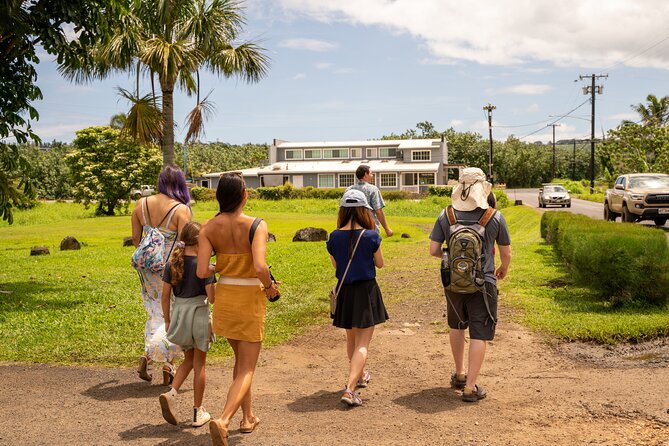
left=132, top=165, right=511, bottom=445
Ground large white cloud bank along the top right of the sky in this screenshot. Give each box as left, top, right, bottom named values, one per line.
left=280, top=0, right=669, bottom=69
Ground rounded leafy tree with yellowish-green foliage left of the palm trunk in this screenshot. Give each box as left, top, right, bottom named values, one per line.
left=65, top=127, right=160, bottom=215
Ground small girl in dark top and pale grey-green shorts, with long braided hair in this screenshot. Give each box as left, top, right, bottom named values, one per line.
left=159, top=222, right=215, bottom=427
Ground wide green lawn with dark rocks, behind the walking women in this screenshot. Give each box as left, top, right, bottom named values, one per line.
left=0, top=199, right=443, bottom=366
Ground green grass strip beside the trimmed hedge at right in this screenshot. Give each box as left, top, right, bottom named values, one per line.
left=501, top=206, right=669, bottom=344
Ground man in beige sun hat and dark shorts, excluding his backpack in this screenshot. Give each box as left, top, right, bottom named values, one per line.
left=430, top=167, right=511, bottom=402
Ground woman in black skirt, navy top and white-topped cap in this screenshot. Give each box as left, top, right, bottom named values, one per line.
left=327, top=190, right=388, bottom=406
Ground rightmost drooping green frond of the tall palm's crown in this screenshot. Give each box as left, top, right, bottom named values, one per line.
left=208, top=43, right=270, bottom=83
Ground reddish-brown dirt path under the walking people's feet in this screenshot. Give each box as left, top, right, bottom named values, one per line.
left=0, top=284, right=669, bottom=446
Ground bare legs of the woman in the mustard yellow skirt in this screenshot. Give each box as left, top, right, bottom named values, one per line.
left=220, top=339, right=262, bottom=429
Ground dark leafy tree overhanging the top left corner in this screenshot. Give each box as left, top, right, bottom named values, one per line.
left=0, top=0, right=123, bottom=223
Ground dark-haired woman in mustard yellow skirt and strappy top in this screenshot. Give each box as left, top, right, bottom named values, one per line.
left=197, top=173, right=279, bottom=445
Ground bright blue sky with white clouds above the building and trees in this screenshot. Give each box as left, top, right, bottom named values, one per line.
left=28, top=0, right=669, bottom=144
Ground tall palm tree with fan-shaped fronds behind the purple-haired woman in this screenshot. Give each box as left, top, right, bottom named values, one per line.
left=59, top=0, right=269, bottom=166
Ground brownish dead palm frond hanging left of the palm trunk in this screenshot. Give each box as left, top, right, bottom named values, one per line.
left=117, top=87, right=163, bottom=143
